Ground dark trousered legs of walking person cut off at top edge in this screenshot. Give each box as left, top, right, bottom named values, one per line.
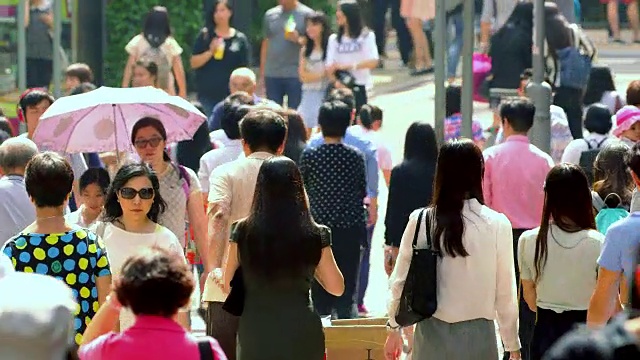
left=373, top=0, right=413, bottom=64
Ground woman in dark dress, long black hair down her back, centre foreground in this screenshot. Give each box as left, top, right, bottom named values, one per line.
left=222, top=156, right=345, bottom=360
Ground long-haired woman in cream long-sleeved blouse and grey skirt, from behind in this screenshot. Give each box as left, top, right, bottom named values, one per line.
left=385, top=140, right=520, bottom=360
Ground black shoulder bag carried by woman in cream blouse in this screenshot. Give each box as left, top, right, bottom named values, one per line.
left=396, top=209, right=440, bottom=327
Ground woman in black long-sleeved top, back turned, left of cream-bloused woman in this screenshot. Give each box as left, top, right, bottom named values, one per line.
left=384, top=122, right=438, bottom=275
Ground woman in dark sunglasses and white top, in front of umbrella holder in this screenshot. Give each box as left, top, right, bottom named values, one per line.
left=91, top=164, right=189, bottom=330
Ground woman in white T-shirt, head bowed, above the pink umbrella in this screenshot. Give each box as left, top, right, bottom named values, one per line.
left=122, top=6, right=187, bottom=98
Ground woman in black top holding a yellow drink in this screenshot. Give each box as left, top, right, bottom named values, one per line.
left=191, top=0, right=251, bottom=116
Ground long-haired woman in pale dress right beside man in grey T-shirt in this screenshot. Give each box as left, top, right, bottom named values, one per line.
left=294, top=11, right=331, bottom=134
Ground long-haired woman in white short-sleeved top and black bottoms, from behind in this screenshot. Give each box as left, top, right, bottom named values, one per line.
left=518, top=164, right=604, bottom=360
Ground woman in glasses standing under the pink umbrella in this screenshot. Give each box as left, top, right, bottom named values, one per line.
left=131, top=117, right=213, bottom=285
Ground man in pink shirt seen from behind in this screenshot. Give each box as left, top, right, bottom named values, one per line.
left=482, top=98, right=554, bottom=360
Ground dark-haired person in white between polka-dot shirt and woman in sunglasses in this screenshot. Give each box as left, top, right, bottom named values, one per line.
left=65, top=168, right=110, bottom=228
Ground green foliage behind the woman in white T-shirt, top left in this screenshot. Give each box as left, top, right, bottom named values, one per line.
left=104, top=0, right=203, bottom=86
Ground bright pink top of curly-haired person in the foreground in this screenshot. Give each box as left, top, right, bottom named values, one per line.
left=78, top=315, right=227, bottom=360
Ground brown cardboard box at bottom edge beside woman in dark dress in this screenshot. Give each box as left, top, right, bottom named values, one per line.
left=324, top=318, right=387, bottom=360
